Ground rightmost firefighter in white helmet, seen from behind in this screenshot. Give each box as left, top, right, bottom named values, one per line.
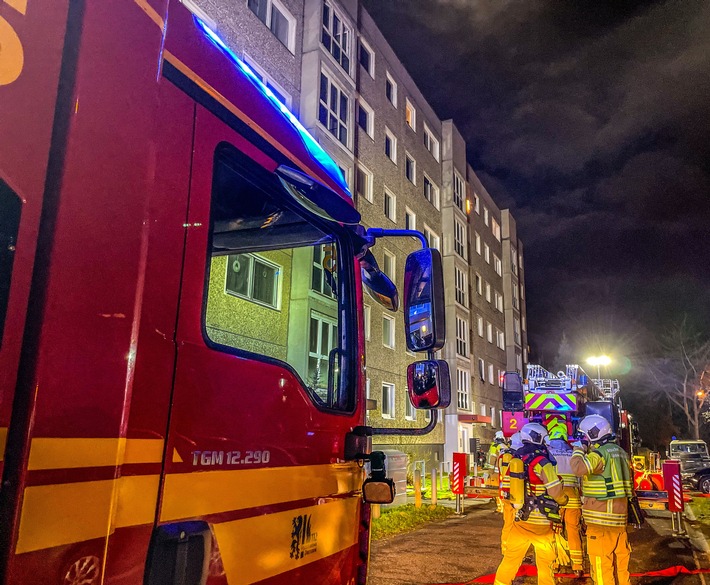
left=570, top=414, right=633, bottom=585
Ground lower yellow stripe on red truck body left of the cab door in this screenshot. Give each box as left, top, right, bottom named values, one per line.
left=15, top=475, right=160, bottom=554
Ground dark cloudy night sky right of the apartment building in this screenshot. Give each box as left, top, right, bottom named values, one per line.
left=364, top=0, right=710, bottom=369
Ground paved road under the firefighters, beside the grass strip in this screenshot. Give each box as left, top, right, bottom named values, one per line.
left=368, top=501, right=710, bottom=585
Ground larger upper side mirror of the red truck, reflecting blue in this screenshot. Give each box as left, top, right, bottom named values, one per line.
left=404, top=248, right=446, bottom=351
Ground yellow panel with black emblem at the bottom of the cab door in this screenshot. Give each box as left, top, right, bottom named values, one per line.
left=212, top=497, right=360, bottom=585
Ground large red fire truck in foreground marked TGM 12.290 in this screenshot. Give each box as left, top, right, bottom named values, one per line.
left=0, top=0, right=450, bottom=585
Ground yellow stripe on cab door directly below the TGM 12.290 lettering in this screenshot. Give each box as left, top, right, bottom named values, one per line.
left=160, top=463, right=364, bottom=522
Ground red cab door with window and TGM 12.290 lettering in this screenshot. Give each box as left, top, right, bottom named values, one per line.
left=149, top=106, right=363, bottom=584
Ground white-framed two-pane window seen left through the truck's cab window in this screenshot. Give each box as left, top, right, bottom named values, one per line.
left=225, top=254, right=281, bottom=309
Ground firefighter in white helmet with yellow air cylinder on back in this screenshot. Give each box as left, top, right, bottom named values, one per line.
left=495, top=423, right=567, bottom=585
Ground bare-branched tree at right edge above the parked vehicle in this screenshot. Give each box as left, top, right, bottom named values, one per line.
left=648, top=318, right=710, bottom=439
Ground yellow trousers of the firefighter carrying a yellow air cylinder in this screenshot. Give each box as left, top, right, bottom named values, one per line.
left=495, top=522, right=557, bottom=585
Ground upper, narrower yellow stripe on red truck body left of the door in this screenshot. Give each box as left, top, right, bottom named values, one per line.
left=27, top=437, right=164, bottom=470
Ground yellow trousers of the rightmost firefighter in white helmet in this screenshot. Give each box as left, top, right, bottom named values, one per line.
left=587, top=524, right=631, bottom=585
